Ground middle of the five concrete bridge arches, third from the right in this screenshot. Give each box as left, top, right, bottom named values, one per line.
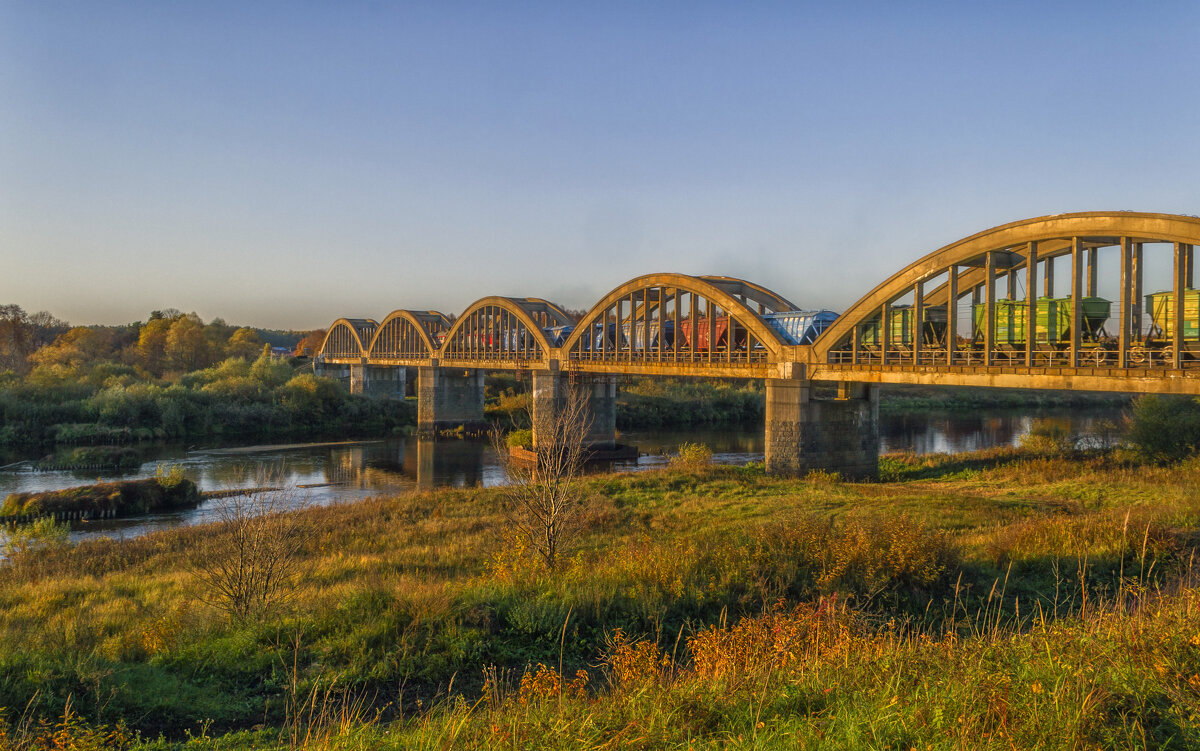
left=438, top=296, right=572, bottom=361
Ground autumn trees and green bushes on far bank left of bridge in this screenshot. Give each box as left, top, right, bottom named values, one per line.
left=0, top=306, right=415, bottom=446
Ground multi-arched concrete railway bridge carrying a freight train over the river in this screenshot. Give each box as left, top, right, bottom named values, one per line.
left=316, top=211, right=1200, bottom=476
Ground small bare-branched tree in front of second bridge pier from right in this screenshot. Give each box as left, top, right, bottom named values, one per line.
left=492, top=381, right=592, bottom=570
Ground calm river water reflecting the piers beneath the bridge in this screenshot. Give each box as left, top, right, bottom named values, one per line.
left=0, top=409, right=1121, bottom=540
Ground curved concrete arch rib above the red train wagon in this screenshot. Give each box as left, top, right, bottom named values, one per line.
left=562, top=274, right=794, bottom=358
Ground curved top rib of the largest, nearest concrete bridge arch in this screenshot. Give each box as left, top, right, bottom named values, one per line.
left=812, top=211, right=1200, bottom=362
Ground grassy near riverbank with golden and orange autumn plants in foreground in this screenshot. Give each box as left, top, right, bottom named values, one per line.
left=0, top=450, right=1200, bottom=749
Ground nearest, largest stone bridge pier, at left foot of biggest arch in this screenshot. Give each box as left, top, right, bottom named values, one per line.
left=766, top=378, right=880, bottom=479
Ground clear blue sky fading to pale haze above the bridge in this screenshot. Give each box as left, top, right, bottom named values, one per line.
left=0, top=0, right=1200, bottom=329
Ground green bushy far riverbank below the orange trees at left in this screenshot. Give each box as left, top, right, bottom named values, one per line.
left=0, top=360, right=416, bottom=446
